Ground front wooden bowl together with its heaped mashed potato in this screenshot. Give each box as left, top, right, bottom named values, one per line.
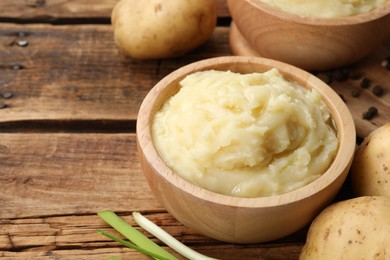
left=137, top=57, right=356, bottom=243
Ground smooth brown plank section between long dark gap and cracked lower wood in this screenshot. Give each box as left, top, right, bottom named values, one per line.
left=0, top=134, right=163, bottom=219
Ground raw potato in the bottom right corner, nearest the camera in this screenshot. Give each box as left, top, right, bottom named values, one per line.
left=299, top=196, right=390, bottom=260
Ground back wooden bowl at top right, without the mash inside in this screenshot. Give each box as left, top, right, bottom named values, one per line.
left=228, top=0, right=390, bottom=70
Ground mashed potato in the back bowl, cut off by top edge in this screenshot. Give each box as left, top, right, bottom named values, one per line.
left=260, top=0, right=388, bottom=18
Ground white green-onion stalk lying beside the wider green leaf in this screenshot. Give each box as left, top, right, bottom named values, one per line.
left=133, top=212, right=219, bottom=260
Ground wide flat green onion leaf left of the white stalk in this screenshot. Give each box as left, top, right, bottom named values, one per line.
left=97, top=210, right=177, bottom=260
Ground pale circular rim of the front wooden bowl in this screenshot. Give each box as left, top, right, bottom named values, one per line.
left=137, top=56, right=356, bottom=208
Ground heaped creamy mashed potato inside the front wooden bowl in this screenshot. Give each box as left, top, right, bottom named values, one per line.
left=152, top=69, right=338, bottom=197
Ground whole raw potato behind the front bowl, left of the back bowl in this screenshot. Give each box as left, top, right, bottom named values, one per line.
left=111, top=0, right=217, bottom=59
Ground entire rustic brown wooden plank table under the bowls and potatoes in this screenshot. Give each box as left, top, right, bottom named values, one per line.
left=0, top=0, right=390, bottom=259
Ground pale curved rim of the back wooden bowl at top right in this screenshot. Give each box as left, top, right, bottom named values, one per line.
left=247, top=0, right=390, bottom=26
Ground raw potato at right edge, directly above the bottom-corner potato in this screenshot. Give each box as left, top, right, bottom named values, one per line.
left=350, top=124, right=390, bottom=196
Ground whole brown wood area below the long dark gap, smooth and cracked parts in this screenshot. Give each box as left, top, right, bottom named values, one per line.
left=0, top=133, right=306, bottom=259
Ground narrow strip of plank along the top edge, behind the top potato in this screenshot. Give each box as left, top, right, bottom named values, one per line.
left=0, top=0, right=230, bottom=22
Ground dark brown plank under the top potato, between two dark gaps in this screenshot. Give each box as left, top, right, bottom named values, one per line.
left=0, top=24, right=230, bottom=122
